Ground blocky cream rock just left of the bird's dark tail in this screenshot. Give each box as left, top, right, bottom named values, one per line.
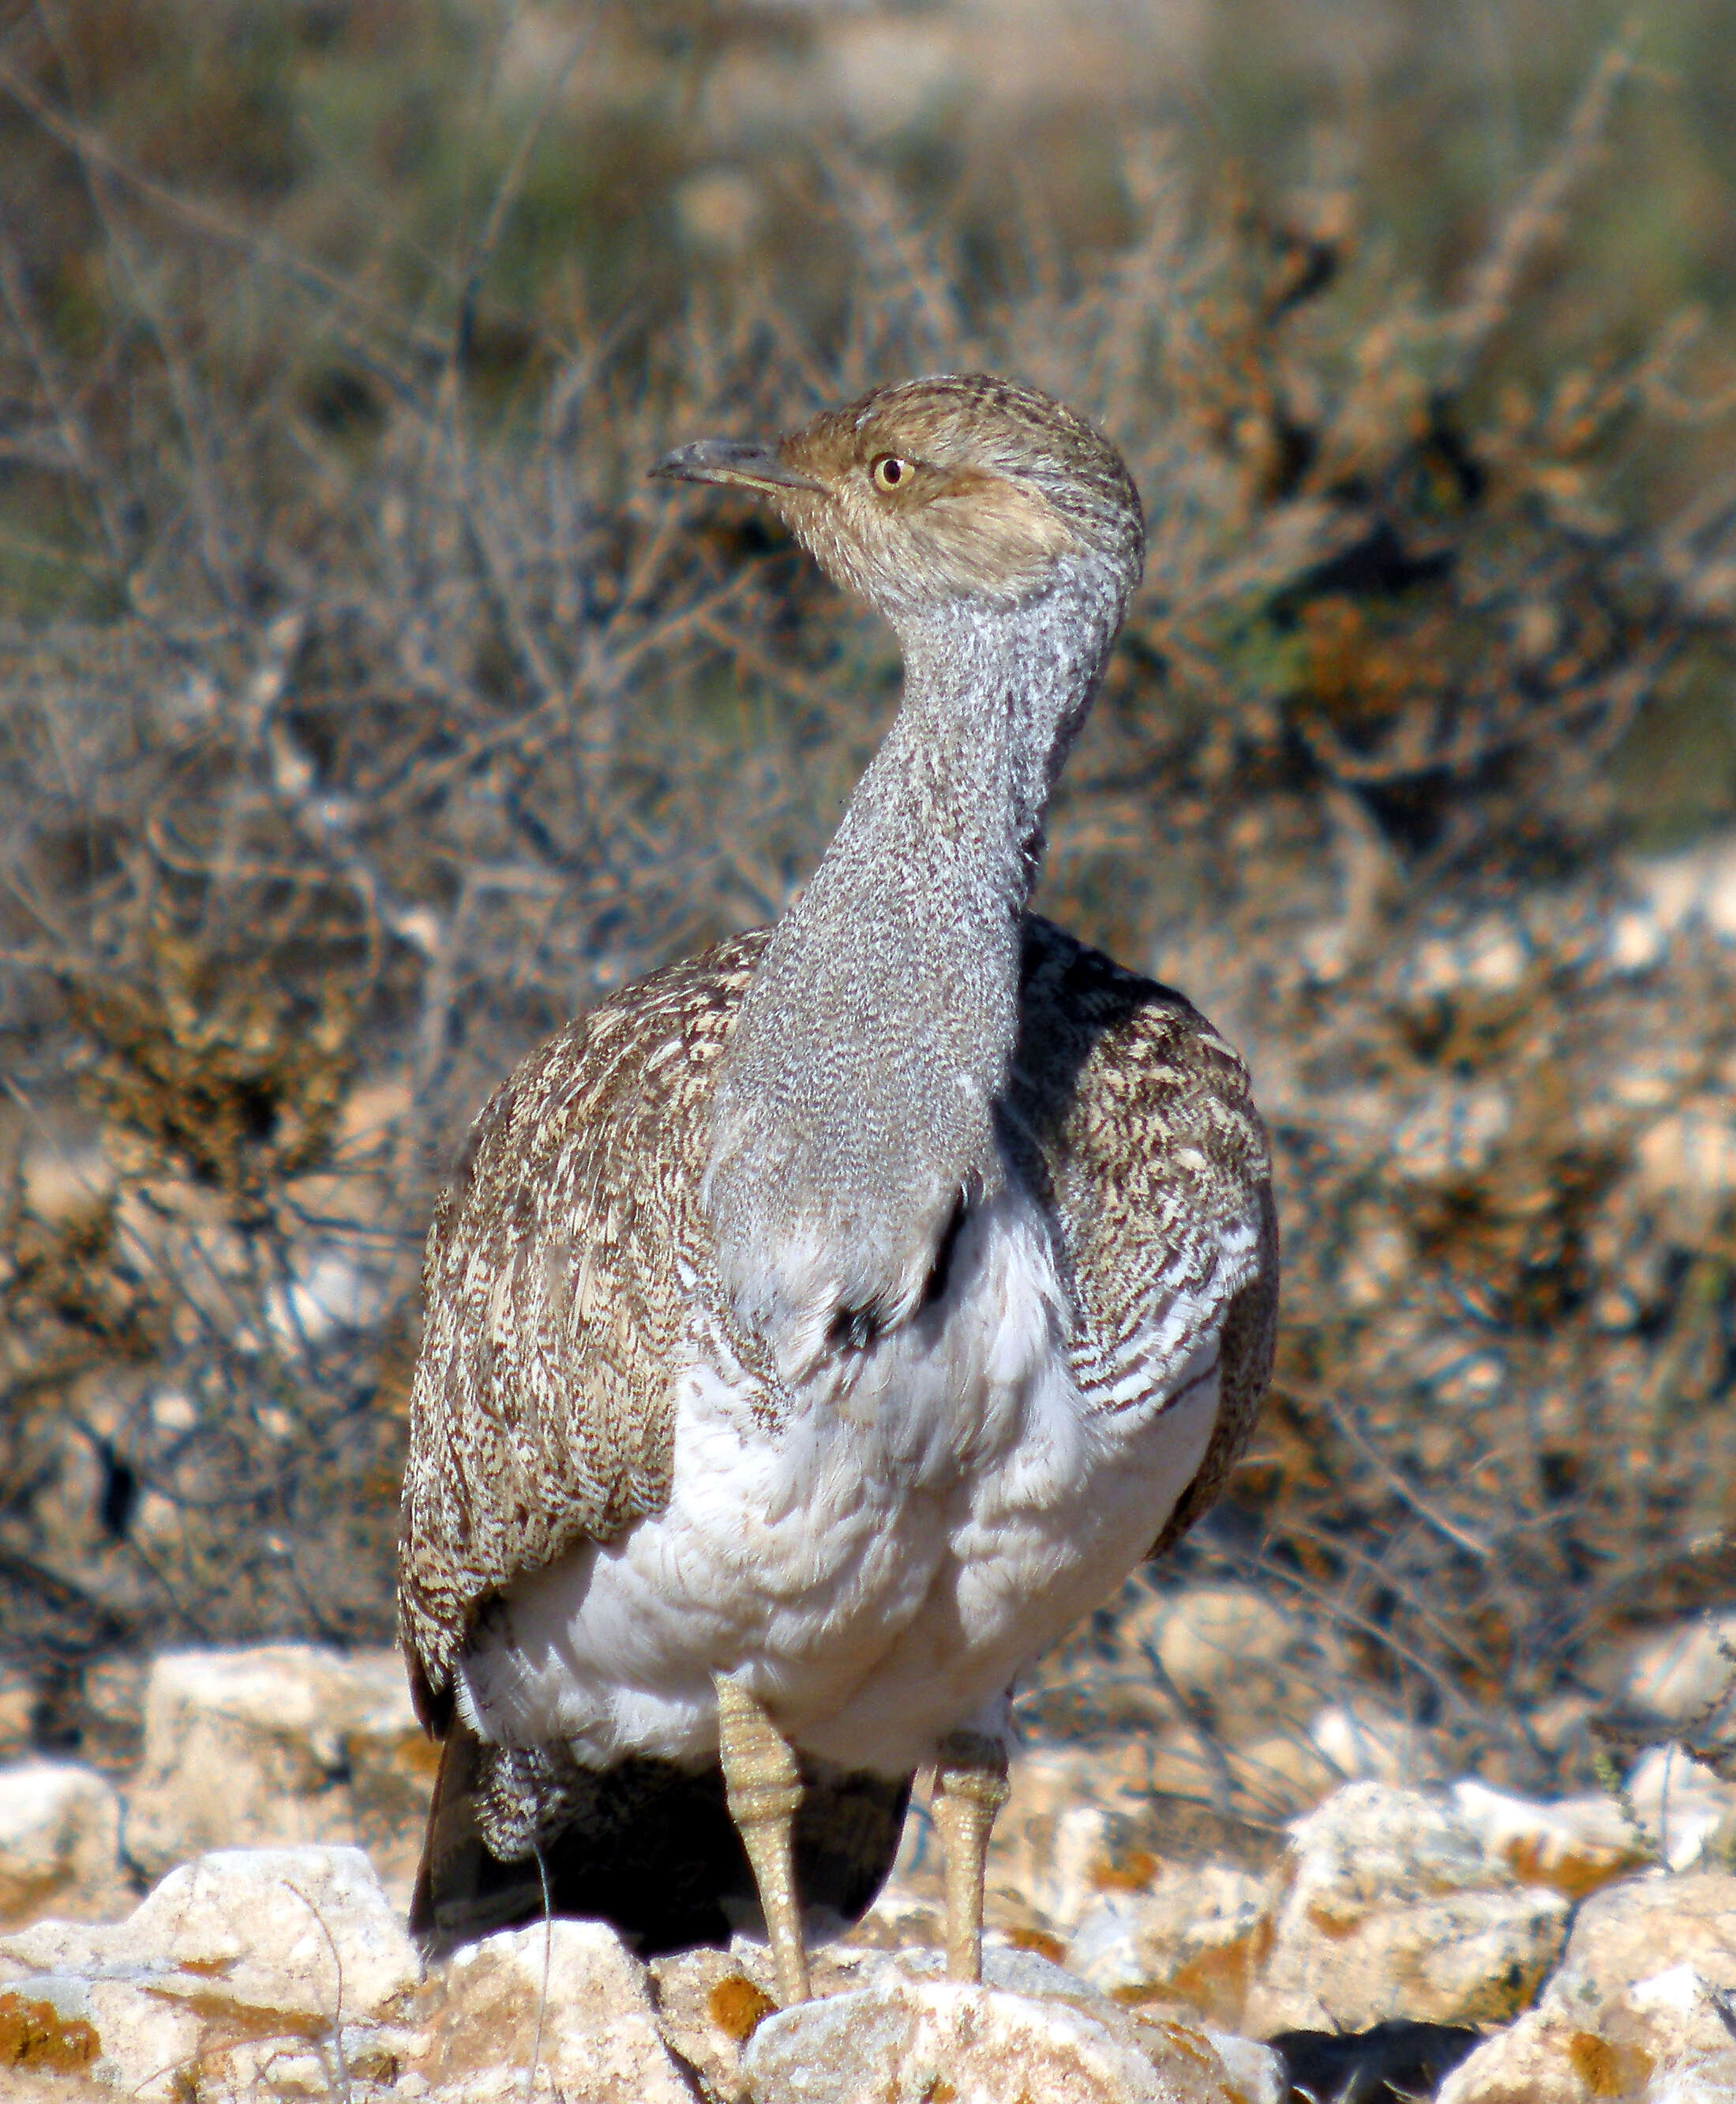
left=126, top=1643, right=437, bottom=1900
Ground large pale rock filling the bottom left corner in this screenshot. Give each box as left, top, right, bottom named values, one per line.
left=0, top=1847, right=421, bottom=2104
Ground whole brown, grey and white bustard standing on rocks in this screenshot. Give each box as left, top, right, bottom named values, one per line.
left=398, top=377, right=1277, bottom=2001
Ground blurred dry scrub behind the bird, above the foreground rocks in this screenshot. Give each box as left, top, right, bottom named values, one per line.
left=0, top=0, right=1736, bottom=1816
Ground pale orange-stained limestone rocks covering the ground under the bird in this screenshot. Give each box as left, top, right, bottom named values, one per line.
left=0, top=1624, right=1736, bottom=2104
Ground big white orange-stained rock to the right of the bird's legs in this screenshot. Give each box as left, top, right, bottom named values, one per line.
left=1246, top=1782, right=1569, bottom=2035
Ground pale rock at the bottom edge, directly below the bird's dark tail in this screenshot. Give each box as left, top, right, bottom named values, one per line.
left=399, top=1921, right=695, bottom=2104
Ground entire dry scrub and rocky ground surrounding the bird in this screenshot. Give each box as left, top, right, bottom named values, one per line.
left=0, top=12, right=1736, bottom=2104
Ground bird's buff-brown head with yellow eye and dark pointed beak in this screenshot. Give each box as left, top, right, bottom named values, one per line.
left=652, top=373, right=1145, bottom=621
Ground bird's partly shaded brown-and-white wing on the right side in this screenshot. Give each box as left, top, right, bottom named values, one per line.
left=1008, top=917, right=1277, bottom=1547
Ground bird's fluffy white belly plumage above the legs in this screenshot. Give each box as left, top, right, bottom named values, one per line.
left=459, top=1191, right=1218, bottom=1776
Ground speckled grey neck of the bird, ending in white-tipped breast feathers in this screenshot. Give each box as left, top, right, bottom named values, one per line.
left=705, top=576, right=1119, bottom=1378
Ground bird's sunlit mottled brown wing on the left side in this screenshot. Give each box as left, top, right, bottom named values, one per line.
left=398, top=932, right=766, bottom=1725
